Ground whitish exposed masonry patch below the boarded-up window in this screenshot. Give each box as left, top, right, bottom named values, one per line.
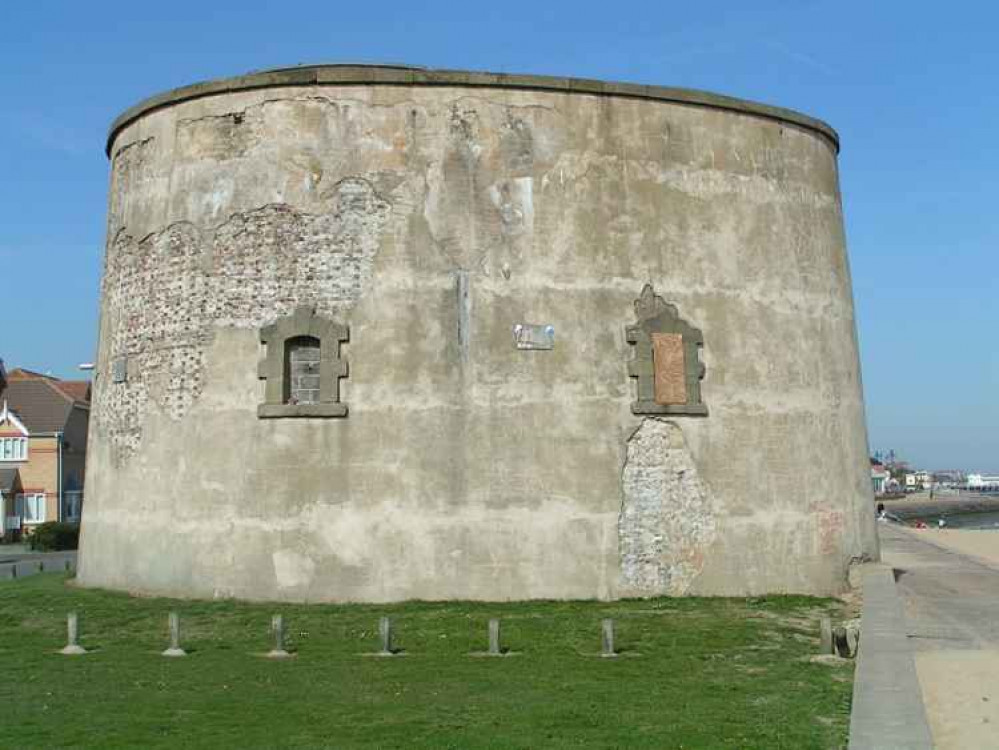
left=618, top=418, right=717, bottom=596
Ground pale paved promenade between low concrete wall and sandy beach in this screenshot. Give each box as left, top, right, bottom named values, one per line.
left=878, top=524, right=999, bottom=750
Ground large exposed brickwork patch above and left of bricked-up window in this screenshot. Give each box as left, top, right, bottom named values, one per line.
left=94, top=178, right=390, bottom=462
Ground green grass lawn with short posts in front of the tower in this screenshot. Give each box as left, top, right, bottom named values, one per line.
left=0, top=574, right=853, bottom=750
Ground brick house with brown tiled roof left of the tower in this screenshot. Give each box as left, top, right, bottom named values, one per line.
left=0, top=369, right=90, bottom=538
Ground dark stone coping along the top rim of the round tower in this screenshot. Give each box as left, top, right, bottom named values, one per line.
left=105, top=64, right=839, bottom=156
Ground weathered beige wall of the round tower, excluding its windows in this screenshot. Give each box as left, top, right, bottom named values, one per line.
left=79, top=67, right=877, bottom=601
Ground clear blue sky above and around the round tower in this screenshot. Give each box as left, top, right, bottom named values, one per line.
left=0, top=0, right=999, bottom=470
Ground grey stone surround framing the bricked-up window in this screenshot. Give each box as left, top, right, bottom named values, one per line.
left=257, top=305, right=350, bottom=419
